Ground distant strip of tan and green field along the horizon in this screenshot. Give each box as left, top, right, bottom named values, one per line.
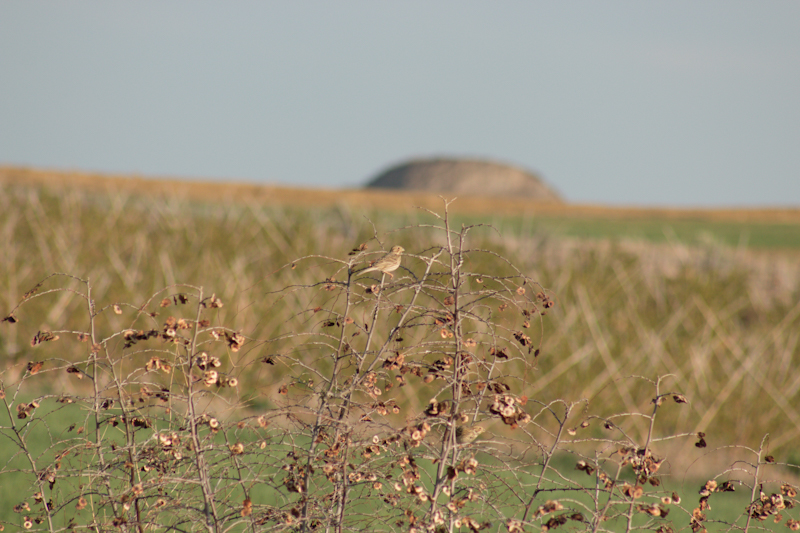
left=0, top=167, right=800, bottom=250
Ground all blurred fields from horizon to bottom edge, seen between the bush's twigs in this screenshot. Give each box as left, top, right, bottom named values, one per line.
left=0, top=169, right=800, bottom=532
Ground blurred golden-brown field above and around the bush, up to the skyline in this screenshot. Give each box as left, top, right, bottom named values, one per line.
left=0, top=165, right=800, bottom=530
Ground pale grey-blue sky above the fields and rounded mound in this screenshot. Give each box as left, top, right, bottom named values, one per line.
left=0, top=0, right=800, bottom=207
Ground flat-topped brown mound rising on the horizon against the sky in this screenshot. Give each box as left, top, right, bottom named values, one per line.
left=367, top=158, right=563, bottom=203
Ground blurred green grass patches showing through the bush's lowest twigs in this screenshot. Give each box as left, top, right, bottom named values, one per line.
left=0, top=388, right=792, bottom=532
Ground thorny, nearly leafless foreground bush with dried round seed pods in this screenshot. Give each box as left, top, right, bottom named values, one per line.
left=0, top=204, right=800, bottom=532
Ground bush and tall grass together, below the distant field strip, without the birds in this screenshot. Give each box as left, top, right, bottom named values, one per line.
left=0, top=174, right=800, bottom=532
